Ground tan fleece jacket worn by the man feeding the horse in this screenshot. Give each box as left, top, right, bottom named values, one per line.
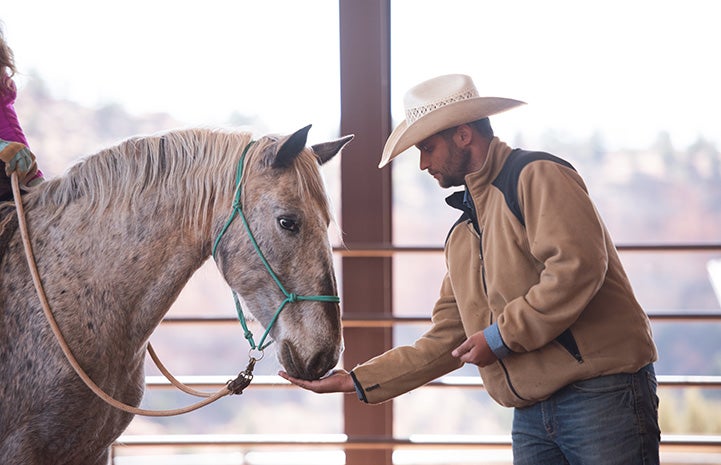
left=353, top=138, right=657, bottom=407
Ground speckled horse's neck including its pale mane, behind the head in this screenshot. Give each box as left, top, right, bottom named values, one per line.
left=21, top=130, right=249, bottom=342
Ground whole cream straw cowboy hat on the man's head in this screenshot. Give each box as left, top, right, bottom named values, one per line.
left=378, top=74, right=525, bottom=168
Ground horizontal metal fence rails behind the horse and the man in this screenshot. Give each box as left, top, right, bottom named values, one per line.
left=112, top=244, right=721, bottom=463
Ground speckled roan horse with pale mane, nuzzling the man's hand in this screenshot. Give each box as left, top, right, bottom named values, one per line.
left=0, top=126, right=353, bottom=465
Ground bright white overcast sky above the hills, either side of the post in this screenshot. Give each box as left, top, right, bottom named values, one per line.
left=0, top=0, right=721, bottom=147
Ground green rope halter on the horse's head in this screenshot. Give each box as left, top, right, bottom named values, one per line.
left=213, top=141, right=340, bottom=351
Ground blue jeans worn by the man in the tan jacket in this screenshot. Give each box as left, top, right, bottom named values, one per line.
left=513, top=364, right=661, bottom=465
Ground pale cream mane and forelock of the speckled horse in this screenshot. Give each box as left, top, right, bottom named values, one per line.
left=25, top=128, right=330, bottom=228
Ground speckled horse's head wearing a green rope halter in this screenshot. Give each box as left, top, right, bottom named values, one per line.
left=213, top=126, right=353, bottom=379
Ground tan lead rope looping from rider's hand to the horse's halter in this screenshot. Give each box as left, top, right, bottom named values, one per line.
left=11, top=173, right=249, bottom=417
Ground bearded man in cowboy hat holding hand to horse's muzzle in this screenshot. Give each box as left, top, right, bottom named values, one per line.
left=281, top=75, right=660, bottom=465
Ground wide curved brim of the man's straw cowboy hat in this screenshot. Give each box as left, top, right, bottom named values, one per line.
left=378, top=97, right=526, bottom=168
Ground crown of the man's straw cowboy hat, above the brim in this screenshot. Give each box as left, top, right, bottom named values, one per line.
left=403, top=74, right=479, bottom=124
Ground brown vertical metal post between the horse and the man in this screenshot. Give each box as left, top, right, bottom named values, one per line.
left=339, top=0, right=393, bottom=465
